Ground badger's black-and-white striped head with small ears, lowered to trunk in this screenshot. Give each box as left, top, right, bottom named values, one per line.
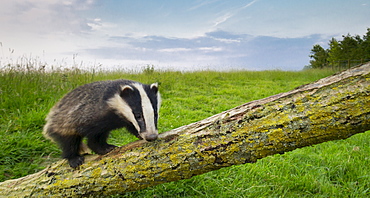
left=107, top=81, right=161, bottom=141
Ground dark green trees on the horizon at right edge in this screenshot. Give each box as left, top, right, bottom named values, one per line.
left=306, top=28, right=370, bottom=69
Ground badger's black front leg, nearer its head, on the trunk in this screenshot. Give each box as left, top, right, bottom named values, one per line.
left=86, top=131, right=116, bottom=155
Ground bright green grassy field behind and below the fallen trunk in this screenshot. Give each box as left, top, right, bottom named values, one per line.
left=0, top=64, right=370, bottom=197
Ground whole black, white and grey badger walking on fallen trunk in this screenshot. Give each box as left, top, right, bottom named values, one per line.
left=43, top=80, right=161, bottom=168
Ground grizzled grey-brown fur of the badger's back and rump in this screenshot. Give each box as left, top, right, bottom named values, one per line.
left=43, top=81, right=113, bottom=139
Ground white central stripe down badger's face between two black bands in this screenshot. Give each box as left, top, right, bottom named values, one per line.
left=133, top=83, right=156, bottom=134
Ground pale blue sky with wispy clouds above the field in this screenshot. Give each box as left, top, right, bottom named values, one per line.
left=0, top=0, right=370, bottom=71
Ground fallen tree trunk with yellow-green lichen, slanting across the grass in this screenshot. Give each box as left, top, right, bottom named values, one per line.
left=0, top=63, right=370, bottom=197
